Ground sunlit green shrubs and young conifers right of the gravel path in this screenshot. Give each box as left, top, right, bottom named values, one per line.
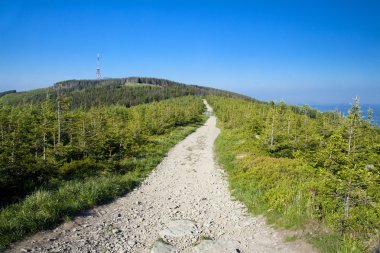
left=207, top=96, right=380, bottom=252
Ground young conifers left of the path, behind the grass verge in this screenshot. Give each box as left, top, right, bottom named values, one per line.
left=0, top=96, right=204, bottom=205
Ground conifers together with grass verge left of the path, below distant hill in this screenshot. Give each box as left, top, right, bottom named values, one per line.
left=0, top=96, right=208, bottom=249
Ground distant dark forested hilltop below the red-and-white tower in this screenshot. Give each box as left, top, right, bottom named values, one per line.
left=0, top=77, right=252, bottom=109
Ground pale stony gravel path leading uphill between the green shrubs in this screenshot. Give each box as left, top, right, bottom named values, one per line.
left=9, top=102, right=313, bottom=253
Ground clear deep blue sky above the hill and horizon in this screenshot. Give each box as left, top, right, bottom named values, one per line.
left=0, top=0, right=380, bottom=104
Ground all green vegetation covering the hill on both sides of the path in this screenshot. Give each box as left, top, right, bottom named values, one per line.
left=0, top=78, right=380, bottom=252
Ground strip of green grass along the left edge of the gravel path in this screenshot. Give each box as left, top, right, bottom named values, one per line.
left=0, top=118, right=206, bottom=251
